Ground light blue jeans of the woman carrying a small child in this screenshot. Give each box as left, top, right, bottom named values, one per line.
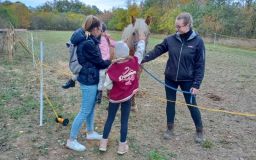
left=70, top=83, right=98, bottom=139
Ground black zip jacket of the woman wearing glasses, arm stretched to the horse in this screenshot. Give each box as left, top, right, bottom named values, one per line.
left=141, top=31, right=205, bottom=89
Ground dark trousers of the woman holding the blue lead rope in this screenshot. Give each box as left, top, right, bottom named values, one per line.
left=165, top=79, right=203, bottom=129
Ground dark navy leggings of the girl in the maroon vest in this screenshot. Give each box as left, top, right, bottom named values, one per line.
left=103, top=99, right=131, bottom=142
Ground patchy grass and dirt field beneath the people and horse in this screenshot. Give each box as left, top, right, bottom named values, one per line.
left=0, top=31, right=256, bottom=160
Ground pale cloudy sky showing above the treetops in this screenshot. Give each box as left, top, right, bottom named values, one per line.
left=7, top=0, right=133, bottom=11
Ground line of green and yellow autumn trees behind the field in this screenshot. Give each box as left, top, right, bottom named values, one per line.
left=0, top=0, right=256, bottom=38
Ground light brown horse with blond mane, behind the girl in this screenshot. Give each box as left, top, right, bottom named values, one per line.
left=122, top=16, right=151, bottom=112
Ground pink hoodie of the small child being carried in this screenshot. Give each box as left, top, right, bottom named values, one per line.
left=99, top=33, right=115, bottom=60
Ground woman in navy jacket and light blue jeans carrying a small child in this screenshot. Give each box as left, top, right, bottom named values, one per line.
left=66, top=15, right=111, bottom=151
